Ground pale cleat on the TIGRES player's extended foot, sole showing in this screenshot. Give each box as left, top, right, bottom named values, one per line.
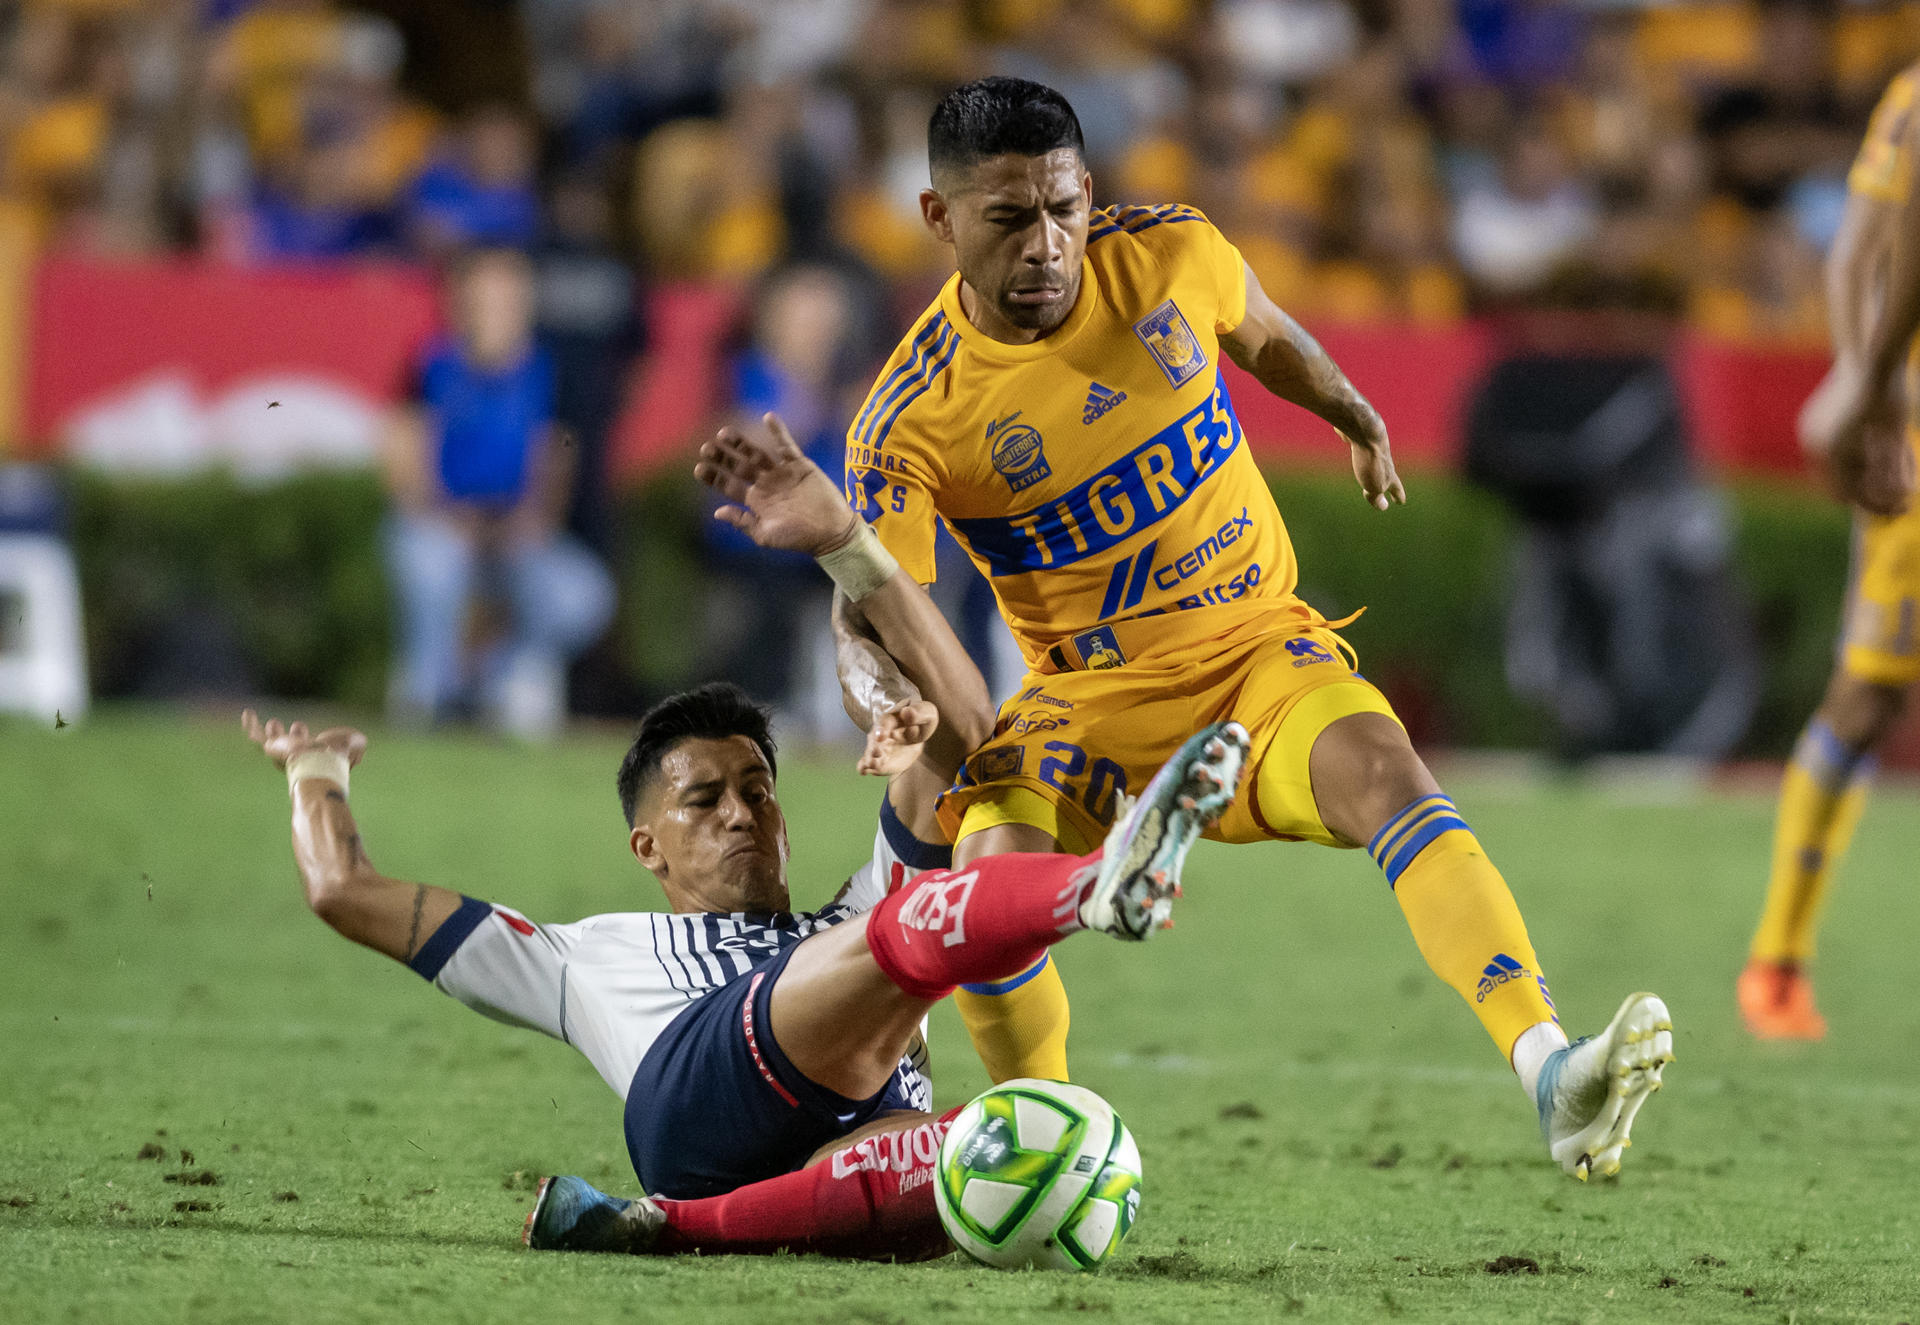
left=1534, top=993, right=1674, bottom=1183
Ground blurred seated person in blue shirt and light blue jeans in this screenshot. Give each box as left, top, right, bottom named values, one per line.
left=386, top=250, right=612, bottom=737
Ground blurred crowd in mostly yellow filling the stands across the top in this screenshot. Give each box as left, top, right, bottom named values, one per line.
left=0, top=0, right=1920, bottom=340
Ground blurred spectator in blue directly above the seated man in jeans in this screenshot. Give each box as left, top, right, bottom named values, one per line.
left=407, top=106, right=540, bottom=257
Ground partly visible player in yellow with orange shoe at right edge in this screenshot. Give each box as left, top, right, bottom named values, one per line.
left=1738, top=65, right=1920, bottom=1039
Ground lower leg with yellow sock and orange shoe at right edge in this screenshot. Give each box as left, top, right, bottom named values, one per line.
left=1736, top=666, right=1910, bottom=1039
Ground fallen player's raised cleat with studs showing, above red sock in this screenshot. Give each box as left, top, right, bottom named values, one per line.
left=1079, top=722, right=1248, bottom=939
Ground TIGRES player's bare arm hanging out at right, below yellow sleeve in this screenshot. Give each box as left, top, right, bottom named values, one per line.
left=1219, top=267, right=1407, bottom=511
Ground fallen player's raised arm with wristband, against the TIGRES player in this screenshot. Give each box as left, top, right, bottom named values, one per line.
left=693, top=415, right=993, bottom=770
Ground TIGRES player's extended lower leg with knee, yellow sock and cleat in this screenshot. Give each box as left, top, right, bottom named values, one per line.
left=1308, top=712, right=1672, bottom=1181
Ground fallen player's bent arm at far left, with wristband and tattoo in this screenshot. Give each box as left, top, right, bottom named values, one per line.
left=240, top=709, right=461, bottom=962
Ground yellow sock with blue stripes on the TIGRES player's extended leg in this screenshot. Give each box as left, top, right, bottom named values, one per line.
left=1367, top=793, right=1559, bottom=1060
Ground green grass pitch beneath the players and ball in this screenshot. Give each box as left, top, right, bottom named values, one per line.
left=0, top=711, right=1920, bottom=1325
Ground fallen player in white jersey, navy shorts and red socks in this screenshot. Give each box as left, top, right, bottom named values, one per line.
left=244, top=417, right=1246, bottom=1260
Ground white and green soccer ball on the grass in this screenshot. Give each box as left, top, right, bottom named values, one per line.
left=933, top=1079, right=1140, bottom=1269
